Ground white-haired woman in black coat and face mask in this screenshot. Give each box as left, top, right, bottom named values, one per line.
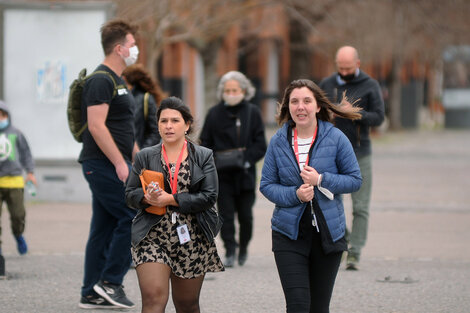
left=200, top=71, right=266, bottom=267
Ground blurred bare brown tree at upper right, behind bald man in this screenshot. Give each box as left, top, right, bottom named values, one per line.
left=284, top=0, right=470, bottom=129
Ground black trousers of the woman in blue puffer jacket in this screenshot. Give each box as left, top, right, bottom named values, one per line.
left=273, top=227, right=342, bottom=313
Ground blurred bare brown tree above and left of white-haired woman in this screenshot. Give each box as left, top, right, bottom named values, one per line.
left=111, top=0, right=267, bottom=104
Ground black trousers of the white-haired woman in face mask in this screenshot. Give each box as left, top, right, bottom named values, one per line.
left=217, top=183, right=255, bottom=255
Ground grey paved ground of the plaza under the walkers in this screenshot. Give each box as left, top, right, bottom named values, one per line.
left=0, top=131, right=470, bottom=313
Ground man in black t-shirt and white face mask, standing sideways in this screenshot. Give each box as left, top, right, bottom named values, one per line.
left=79, top=20, right=138, bottom=309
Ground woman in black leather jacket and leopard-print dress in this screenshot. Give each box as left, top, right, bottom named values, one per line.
left=126, top=97, right=224, bottom=312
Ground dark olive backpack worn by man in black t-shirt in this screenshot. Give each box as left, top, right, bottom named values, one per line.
left=67, top=68, right=117, bottom=142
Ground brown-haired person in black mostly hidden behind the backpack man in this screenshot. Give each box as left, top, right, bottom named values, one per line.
left=122, top=64, right=164, bottom=149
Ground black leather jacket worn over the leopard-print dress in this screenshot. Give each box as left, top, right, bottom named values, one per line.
left=126, top=142, right=219, bottom=246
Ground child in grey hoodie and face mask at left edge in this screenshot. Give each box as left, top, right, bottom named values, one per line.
left=0, top=100, right=36, bottom=255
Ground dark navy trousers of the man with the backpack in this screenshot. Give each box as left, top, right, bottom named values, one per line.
left=82, top=159, right=135, bottom=296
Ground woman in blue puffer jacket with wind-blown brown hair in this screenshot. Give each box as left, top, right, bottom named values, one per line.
left=260, top=79, right=362, bottom=313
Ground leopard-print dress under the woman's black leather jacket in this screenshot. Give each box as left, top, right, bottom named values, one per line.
left=132, top=155, right=224, bottom=278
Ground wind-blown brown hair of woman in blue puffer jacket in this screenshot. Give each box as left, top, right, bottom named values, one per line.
left=277, top=79, right=361, bottom=125
